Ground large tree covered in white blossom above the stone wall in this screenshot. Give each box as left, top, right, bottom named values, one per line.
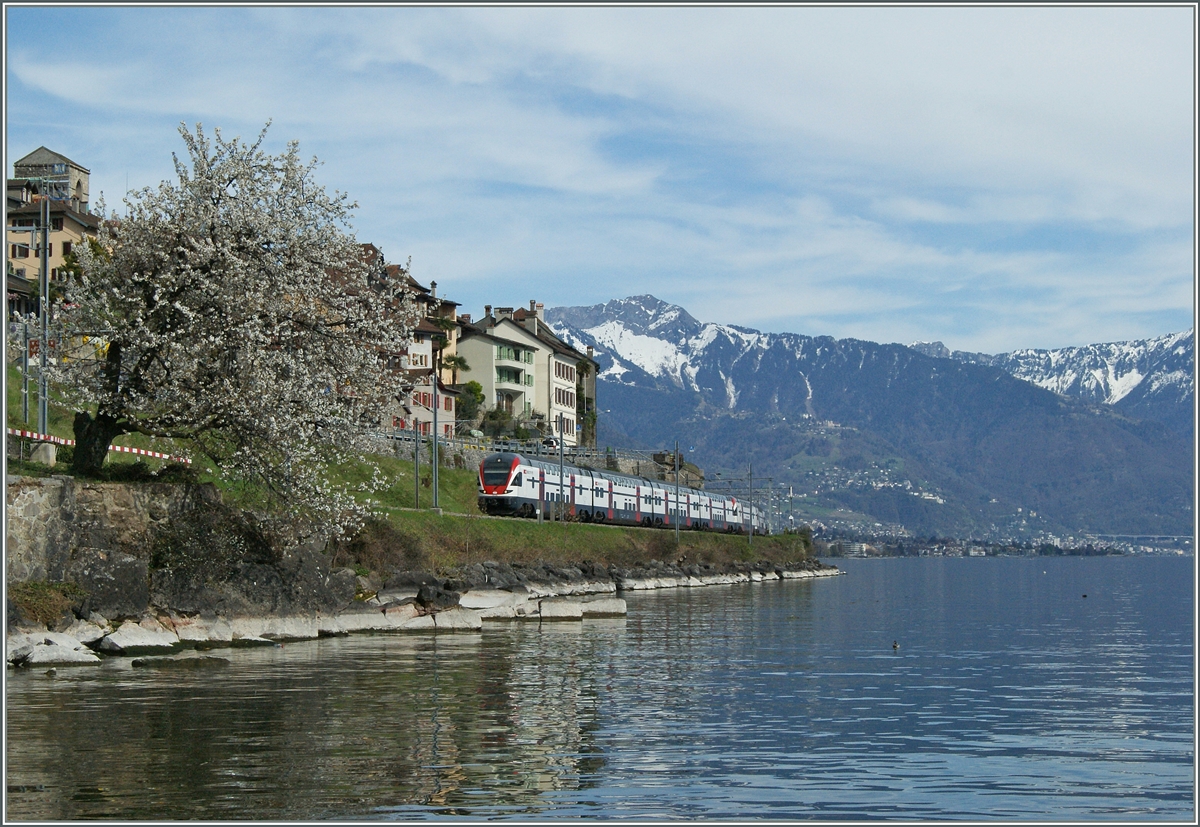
left=54, top=125, right=418, bottom=533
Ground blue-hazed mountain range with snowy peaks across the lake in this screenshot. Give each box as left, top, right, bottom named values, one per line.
left=546, top=295, right=1194, bottom=538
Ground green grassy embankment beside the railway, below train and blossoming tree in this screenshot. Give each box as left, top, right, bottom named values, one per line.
left=7, top=365, right=804, bottom=573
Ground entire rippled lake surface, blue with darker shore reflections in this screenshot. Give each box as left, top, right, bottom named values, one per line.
left=6, top=557, right=1195, bottom=821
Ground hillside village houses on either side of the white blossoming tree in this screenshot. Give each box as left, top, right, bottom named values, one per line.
left=5, top=146, right=598, bottom=448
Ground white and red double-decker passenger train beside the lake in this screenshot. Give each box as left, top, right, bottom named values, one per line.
left=479, top=451, right=767, bottom=534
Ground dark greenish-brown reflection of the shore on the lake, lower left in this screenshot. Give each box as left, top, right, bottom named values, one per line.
left=7, top=621, right=624, bottom=820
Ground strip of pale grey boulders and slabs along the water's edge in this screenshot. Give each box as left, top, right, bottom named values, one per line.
left=6, top=561, right=841, bottom=666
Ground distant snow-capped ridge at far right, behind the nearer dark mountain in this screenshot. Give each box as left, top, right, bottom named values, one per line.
left=910, top=330, right=1195, bottom=431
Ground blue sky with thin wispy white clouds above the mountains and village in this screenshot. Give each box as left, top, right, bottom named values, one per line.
left=5, top=6, right=1196, bottom=353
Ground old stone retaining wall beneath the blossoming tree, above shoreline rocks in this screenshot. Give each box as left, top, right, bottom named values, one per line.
left=5, top=477, right=354, bottom=618
